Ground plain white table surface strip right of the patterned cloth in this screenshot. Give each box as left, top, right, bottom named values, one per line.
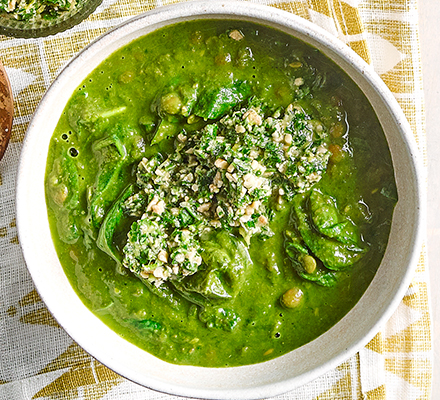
left=419, top=0, right=440, bottom=400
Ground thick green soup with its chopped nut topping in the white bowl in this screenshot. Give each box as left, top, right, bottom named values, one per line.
left=46, top=20, right=397, bottom=367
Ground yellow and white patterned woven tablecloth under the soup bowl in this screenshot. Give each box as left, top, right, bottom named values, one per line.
left=0, top=0, right=432, bottom=400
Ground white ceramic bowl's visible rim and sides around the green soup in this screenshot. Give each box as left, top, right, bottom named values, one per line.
left=17, top=1, right=424, bottom=399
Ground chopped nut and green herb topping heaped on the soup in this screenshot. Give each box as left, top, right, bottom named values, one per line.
left=123, top=98, right=331, bottom=286
